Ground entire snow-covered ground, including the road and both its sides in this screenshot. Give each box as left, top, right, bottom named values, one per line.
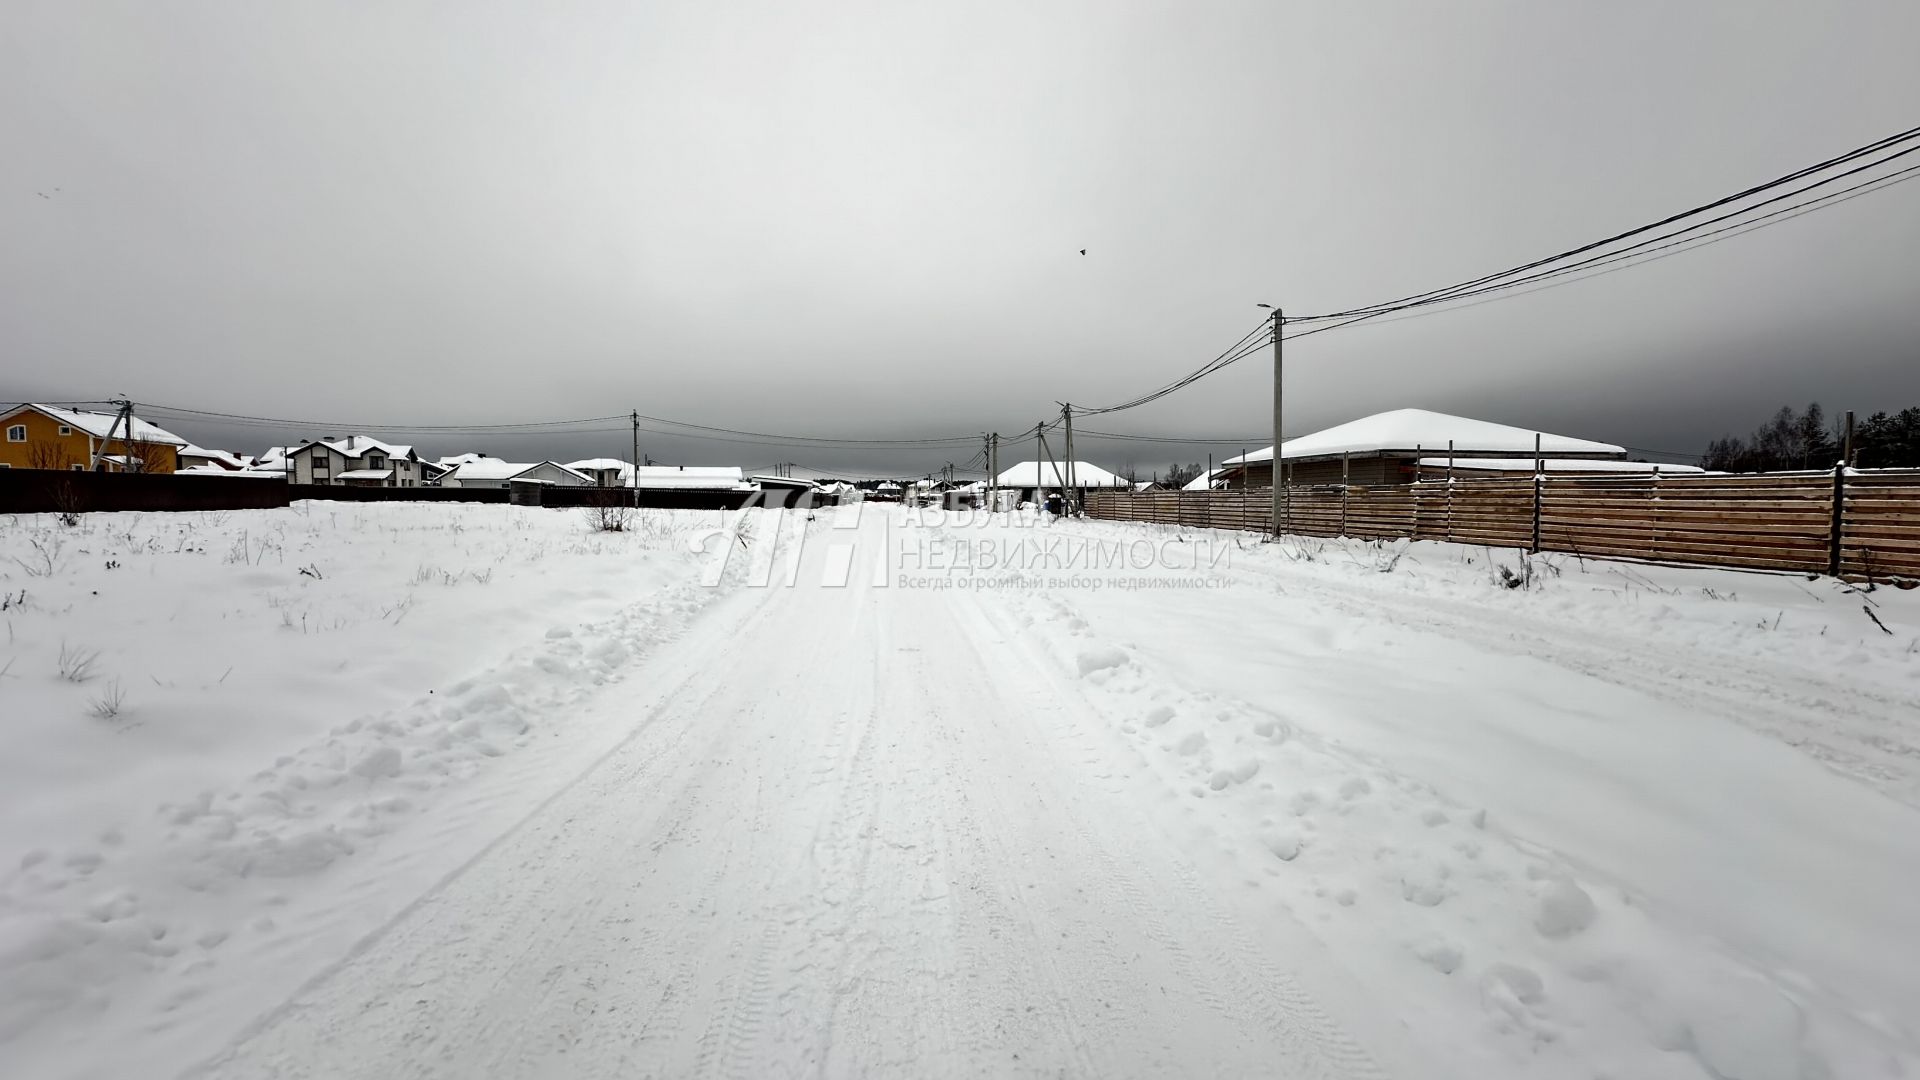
left=0, top=503, right=1920, bottom=1080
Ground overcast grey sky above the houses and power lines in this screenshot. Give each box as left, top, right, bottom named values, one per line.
left=0, top=0, right=1920, bottom=473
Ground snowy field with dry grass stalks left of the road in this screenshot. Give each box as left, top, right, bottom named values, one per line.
left=0, top=503, right=741, bottom=1076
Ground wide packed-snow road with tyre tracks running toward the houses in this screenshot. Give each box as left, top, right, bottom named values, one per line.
left=183, top=515, right=1402, bottom=1078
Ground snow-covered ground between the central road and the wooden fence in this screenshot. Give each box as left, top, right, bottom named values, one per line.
left=948, top=507, right=1920, bottom=1078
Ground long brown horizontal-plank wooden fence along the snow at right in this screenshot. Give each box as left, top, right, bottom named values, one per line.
left=1087, top=469, right=1920, bottom=578
